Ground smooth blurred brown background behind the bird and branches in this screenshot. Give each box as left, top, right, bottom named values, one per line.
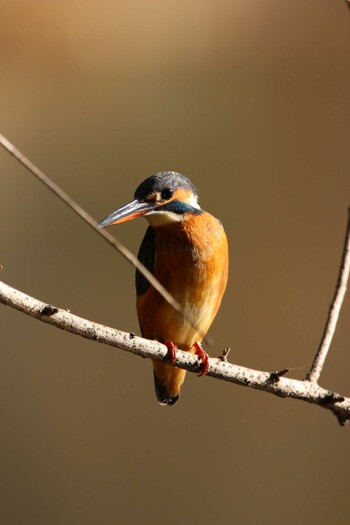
left=0, top=0, right=350, bottom=525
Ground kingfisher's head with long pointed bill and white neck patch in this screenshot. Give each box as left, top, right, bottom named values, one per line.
left=98, top=171, right=202, bottom=228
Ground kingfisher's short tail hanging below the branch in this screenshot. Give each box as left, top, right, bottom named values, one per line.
left=153, top=361, right=186, bottom=406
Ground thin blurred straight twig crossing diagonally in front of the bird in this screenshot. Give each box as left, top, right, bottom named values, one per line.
left=0, top=134, right=206, bottom=342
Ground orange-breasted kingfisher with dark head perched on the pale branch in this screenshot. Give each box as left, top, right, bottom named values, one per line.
left=98, top=171, right=228, bottom=406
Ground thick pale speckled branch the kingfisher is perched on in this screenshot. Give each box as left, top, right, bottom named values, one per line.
left=0, top=281, right=350, bottom=425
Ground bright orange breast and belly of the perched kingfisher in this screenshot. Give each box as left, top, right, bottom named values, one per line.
left=137, top=212, right=228, bottom=350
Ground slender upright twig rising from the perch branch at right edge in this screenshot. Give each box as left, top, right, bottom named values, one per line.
left=307, top=209, right=350, bottom=383
